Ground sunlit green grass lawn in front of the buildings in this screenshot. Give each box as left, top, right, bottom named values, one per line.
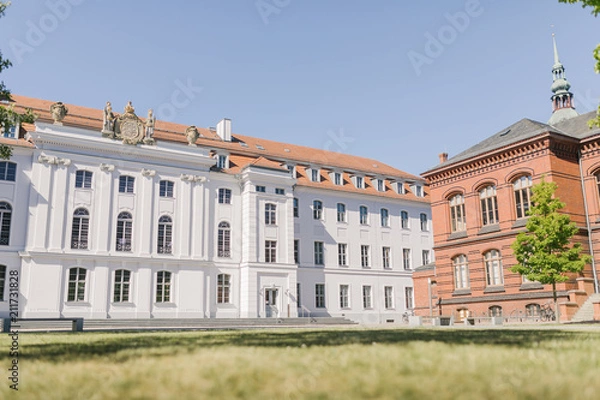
left=0, top=328, right=600, bottom=400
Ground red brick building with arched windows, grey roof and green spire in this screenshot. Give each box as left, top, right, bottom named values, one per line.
left=414, top=35, right=600, bottom=321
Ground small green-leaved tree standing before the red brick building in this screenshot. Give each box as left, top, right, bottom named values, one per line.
left=511, top=179, right=591, bottom=317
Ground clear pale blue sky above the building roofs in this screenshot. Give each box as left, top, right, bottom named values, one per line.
left=0, top=0, right=600, bottom=174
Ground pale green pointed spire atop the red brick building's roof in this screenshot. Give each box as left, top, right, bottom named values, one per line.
left=548, top=33, right=579, bottom=125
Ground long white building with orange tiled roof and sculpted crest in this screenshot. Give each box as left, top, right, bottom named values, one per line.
left=0, top=96, right=433, bottom=323
